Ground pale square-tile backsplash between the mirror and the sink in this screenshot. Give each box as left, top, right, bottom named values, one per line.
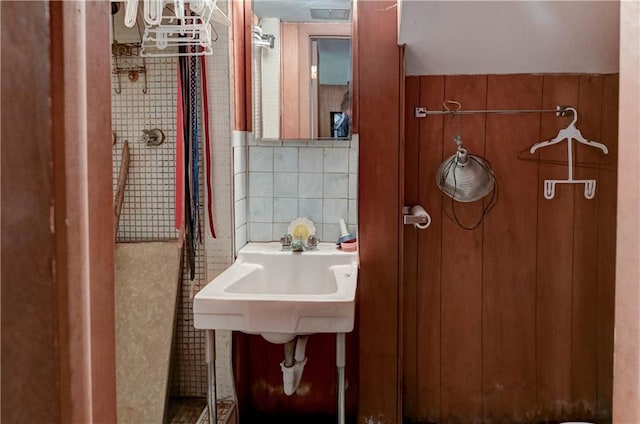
left=234, top=135, right=358, bottom=247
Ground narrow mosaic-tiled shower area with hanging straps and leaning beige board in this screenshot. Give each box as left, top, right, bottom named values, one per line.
left=110, top=0, right=233, bottom=423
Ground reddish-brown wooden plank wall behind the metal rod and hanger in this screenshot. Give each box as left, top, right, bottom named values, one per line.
left=402, top=75, right=618, bottom=423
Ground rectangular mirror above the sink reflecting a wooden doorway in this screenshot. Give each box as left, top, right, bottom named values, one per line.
left=251, top=0, right=353, bottom=140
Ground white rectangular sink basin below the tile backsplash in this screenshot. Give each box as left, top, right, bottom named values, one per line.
left=193, top=242, right=358, bottom=343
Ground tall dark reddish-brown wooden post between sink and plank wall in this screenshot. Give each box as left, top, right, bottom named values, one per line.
left=355, top=0, right=401, bottom=423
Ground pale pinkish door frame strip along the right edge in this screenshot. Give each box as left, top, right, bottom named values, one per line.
left=613, top=1, right=640, bottom=423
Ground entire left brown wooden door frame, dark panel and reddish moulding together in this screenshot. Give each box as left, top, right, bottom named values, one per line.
left=1, top=1, right=116, bottom=423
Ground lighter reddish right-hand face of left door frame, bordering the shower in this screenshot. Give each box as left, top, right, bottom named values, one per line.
left=84, top=2, right=116, bottom=422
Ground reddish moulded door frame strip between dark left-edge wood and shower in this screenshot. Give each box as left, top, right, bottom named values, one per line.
left=50, top=1, right=116, bottom=422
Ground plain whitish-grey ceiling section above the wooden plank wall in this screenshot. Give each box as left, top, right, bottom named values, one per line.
left=398, top=0, right=620, bottom=75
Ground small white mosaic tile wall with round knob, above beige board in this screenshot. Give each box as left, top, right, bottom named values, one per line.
left=111, top=58, right=178, bottom=241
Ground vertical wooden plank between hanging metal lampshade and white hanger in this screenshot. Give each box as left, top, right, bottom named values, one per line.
left=482, top=75, right=542, bottom=422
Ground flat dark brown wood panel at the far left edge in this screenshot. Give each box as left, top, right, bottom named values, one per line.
left=0, top=2, right=60, bottom=423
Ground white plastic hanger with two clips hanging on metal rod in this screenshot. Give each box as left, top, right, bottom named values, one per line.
left=530, top=106, right=609, bottom=199
